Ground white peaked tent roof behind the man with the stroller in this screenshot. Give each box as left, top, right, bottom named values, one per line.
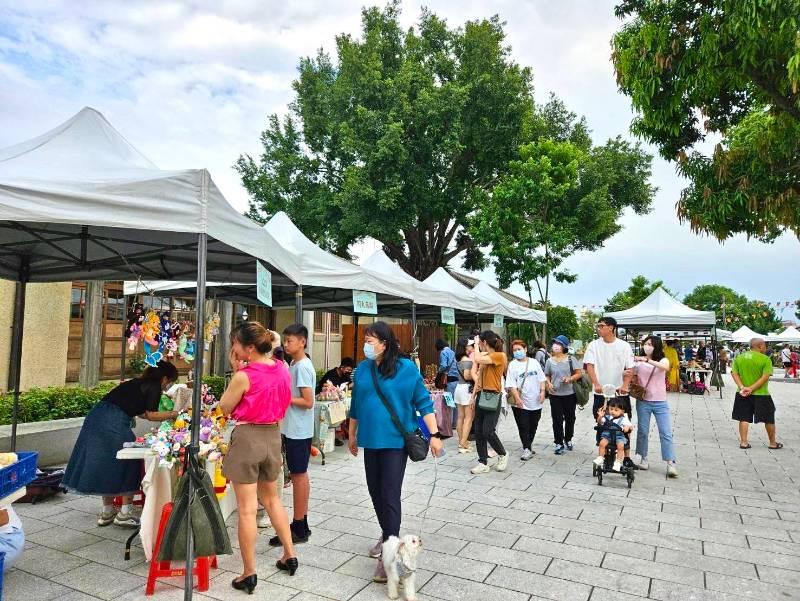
left=606, top=287, right=716, bottom=330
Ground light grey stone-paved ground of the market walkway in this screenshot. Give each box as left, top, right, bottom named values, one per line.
left=5, top=381, right=800, bottom=601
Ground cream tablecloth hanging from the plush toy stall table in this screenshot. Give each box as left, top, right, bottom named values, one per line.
left=117, top=448, right=236, bottom=561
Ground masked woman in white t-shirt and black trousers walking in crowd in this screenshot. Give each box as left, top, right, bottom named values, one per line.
left=506, top=340, right=547, bottom=461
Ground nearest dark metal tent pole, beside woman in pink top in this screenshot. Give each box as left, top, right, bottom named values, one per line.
left=183, top=233, right=208, bottom=601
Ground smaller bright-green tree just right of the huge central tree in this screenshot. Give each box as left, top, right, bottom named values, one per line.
left=470, top=97, right=654, bottom=335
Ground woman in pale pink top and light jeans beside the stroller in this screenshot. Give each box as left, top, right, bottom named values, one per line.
left=634, top=336, right=678, bottom=478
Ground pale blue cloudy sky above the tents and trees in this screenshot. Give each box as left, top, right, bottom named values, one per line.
left=0, top=0, right=800, bottom=318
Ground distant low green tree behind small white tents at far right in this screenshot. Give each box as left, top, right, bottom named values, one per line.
left=683, top=284, right=783, bottom=334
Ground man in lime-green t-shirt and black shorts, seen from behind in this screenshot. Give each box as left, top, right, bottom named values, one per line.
left=731, top=338, right=783, bottom=449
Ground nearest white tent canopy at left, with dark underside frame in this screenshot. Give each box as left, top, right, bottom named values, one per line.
left=0, top=108, right=285, bottom=281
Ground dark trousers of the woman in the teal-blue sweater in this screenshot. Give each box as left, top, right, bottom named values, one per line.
left=364, top=449, right=408, bottom=542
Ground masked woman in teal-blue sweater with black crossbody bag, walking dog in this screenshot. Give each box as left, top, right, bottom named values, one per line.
left=349, top=321, right=442, bottom=582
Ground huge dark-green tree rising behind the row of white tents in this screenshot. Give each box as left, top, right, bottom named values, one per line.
left=236, top=0, right=535, bottom=279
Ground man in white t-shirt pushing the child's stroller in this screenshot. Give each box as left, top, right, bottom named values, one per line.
left=583, top=317, right=634, bottom=453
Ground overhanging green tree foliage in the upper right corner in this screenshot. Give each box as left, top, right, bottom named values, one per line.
left=612, top=0, right=800, bottom=241
